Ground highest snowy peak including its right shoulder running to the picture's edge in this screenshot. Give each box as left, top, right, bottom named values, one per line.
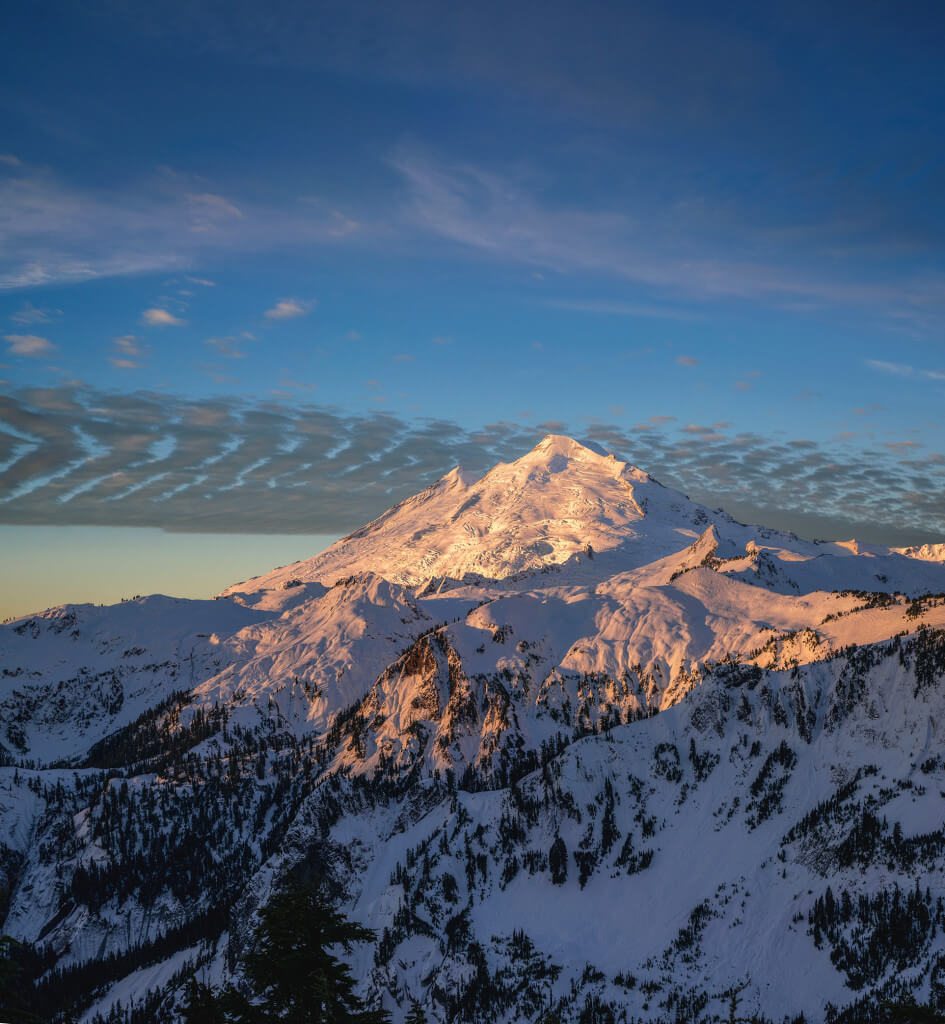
left=224, top=434, right=945, bottom=602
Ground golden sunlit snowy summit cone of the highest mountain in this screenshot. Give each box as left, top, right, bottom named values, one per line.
left=225, top=434, right=708, bottom=589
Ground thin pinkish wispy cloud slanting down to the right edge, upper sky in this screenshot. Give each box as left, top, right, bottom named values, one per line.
left=390, top=148, right=945, bottom=327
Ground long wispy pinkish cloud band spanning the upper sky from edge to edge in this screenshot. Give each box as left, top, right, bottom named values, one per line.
left=0, top=147, right=945, bottom=332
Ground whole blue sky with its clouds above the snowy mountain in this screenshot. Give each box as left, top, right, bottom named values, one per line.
left=0, top=0, right=945, bottom=614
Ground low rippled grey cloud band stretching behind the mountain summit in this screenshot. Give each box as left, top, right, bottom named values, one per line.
left=0, top=385, right=945, bottom=544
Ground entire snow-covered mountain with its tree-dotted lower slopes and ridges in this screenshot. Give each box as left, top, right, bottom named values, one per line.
left=0, top=436, right=945, bottom=1022
